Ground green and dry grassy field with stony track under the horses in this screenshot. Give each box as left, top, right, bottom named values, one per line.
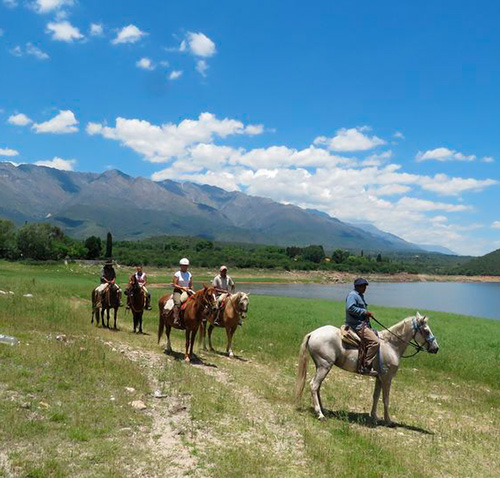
left=0, top=262, right=500, bottom=477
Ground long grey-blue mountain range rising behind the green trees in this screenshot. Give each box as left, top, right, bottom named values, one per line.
left=0, top=162, right=452, bottom=253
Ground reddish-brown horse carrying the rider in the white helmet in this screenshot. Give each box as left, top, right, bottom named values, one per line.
left=158, top=286, right=215, bottom=363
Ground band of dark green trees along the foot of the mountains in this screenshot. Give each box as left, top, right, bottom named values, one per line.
left=0, top=219, right=472, bottom=273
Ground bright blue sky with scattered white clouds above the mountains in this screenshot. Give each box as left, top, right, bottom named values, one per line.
left=0, top=0, right=500, bottom=255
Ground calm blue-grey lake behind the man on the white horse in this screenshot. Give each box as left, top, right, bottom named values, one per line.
left=239, top=282, right=500, bottom=320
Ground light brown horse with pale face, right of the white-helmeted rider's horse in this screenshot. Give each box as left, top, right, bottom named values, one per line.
left=200, top=292, right=249, bottom=358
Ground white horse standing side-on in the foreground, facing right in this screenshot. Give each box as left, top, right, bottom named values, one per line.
left=295, top=312, right=439, bottom=426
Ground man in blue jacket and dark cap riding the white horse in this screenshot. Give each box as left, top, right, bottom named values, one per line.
left=345, top=277, right=380, bottom=377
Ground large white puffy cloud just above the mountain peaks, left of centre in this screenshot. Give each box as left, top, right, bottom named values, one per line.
left=87, top=113, right=266, bottom=163
